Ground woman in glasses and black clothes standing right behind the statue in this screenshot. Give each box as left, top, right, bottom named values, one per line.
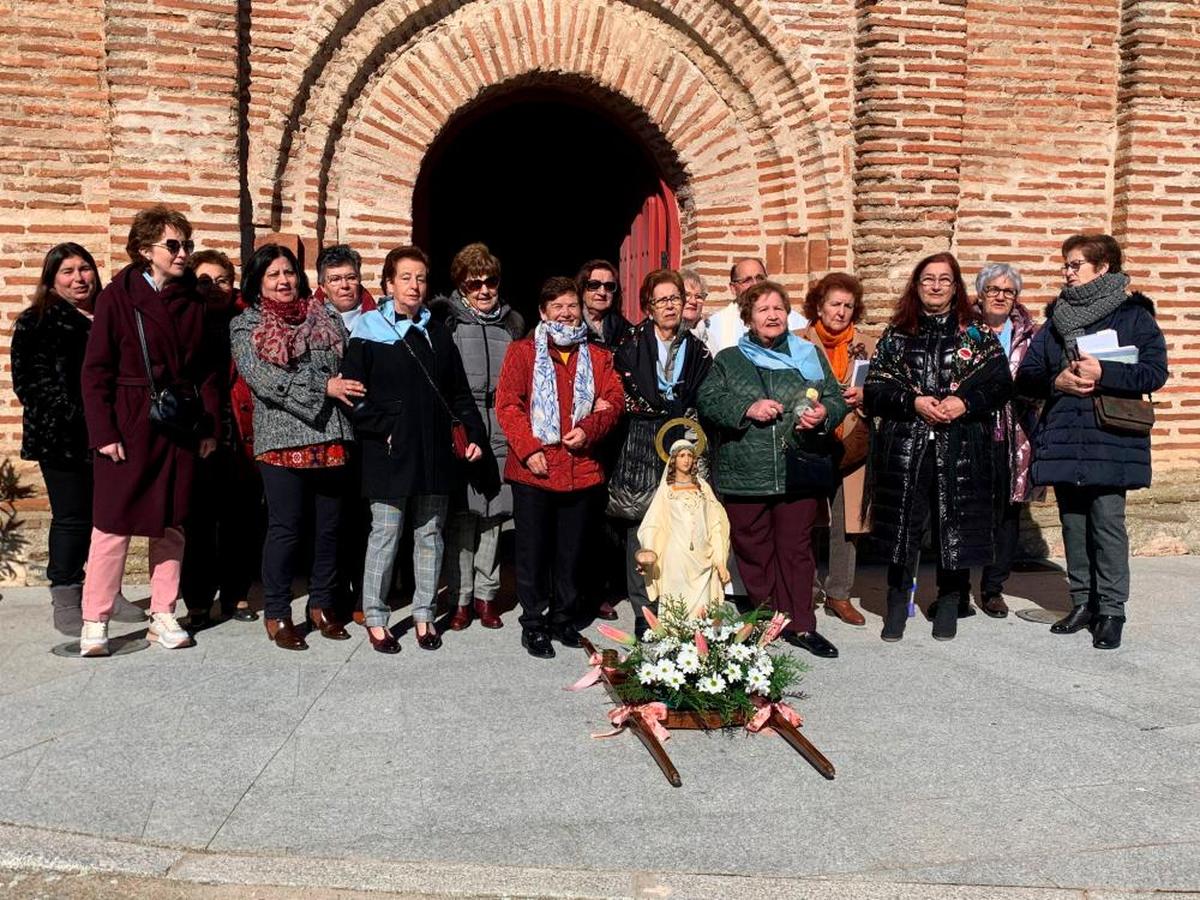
left=607, top=269, right=724, bottom=636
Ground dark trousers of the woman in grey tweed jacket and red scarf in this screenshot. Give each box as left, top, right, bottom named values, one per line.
left=258, top=462, right=346, bottom=619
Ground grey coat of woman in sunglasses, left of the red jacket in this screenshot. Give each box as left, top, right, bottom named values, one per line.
left=430, top=290, right=524, bottom=517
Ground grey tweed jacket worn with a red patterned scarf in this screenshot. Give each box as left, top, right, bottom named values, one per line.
left=229, top=304, right=354, bottom=455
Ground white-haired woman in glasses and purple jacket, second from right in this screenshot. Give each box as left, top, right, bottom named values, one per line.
left=974, top=263, right=1042, bottom=619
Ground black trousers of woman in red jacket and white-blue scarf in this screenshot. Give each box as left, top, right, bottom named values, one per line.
left=512, top=484, right=602, bottom=630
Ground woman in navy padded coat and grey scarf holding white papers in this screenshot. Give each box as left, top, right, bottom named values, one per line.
left=1016, top=234, right=1168, bottom=650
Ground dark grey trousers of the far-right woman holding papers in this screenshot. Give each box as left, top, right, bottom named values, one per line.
left=1054, top=485, right=1129, bottom=618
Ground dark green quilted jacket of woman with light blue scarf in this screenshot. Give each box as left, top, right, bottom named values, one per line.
left=698, top=335, right=847, bottom=497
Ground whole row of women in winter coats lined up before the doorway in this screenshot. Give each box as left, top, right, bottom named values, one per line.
left=12, top=206, right=1168, bottom=656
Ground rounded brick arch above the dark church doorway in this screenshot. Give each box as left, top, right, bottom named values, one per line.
left=250, top=0, right=848, bottom=286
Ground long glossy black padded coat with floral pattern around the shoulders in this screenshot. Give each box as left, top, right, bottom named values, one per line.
left=863, top=316, right=1013, bottom=569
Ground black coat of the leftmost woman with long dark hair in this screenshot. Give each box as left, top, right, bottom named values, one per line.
left=11, top=300, right=91, bottom=464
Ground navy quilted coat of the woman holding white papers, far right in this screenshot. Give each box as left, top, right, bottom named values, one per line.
left=1016, top=293, right=1166, bottom=488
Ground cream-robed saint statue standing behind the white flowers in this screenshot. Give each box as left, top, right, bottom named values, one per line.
left=635, top=437, right=730, bottom=616
